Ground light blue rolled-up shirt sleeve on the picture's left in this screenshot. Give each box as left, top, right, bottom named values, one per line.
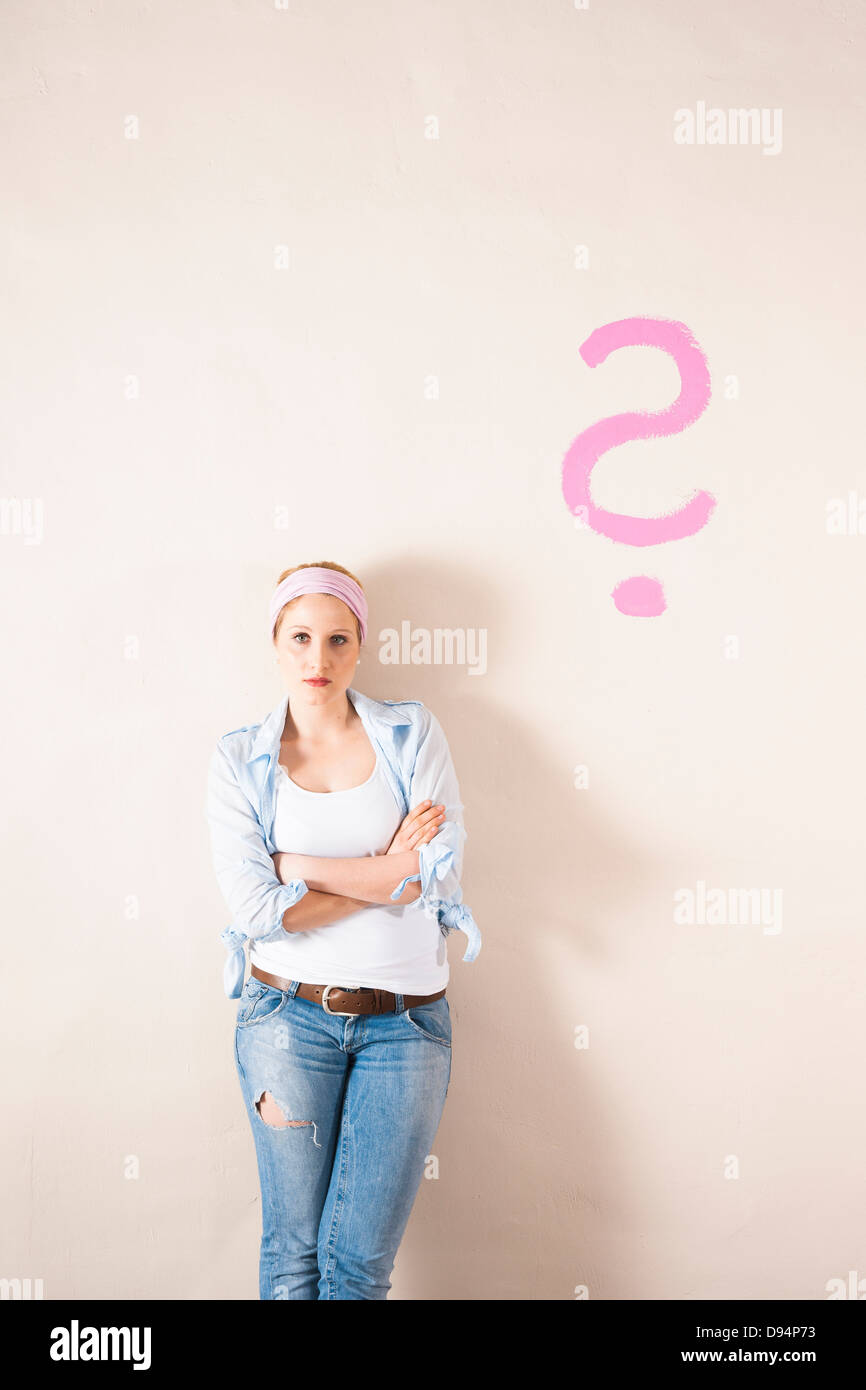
left=207, top=744, right=309, bottom=998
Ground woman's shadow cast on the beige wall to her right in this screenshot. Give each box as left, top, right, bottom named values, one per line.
left=356, top=563, right=664, bottom=1300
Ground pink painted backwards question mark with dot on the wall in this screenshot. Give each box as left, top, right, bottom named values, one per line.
left=563, top=318, right=716, bottom=617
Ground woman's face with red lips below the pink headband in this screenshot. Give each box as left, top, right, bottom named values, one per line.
left=274, top=594, right=361, bottom=705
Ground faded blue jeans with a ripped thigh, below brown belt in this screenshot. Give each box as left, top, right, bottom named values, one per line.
left=235, top=976, right=452, bottom=1300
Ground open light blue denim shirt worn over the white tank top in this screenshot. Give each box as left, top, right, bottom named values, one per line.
left=206, top=688, right=481, bottom=999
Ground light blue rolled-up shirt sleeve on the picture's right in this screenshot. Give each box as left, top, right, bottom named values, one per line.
left=391, top=709, right=481, bottom=962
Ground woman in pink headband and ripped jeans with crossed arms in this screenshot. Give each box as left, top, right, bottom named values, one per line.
left=207, top=562, right=481, bottom=1300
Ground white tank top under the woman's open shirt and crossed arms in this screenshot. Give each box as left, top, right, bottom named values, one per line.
left=250, top=751, right=449, bottom=994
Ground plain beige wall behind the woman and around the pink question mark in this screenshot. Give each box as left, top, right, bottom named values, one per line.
left=0, top=0, right=866, bottom=1300
